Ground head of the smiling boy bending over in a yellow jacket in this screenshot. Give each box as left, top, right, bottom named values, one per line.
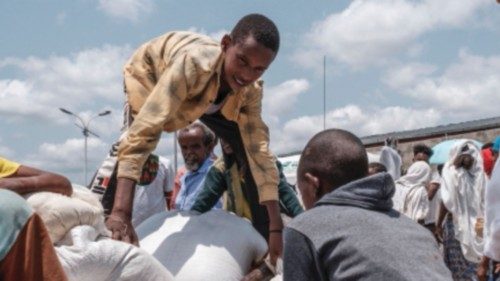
left=221, top=14, right=280, bottom=91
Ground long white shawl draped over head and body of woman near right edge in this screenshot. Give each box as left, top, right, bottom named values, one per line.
left=440, top=140, right=486, bottom=263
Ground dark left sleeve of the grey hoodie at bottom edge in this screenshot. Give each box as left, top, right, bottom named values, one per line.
left=283, top=227, right=326, bottom=281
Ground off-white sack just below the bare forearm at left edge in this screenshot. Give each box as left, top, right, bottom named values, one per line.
left=24, top=184, right=110, bottom=241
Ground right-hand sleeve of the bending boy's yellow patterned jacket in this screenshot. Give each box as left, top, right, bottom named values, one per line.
left=238, top=83, right=279, bottom=203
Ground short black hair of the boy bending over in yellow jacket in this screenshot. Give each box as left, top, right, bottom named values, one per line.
left=231, top=14, right=280, bottom=53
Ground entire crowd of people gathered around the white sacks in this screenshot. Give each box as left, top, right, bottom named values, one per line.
left=0, top=14, right=500, bottom=280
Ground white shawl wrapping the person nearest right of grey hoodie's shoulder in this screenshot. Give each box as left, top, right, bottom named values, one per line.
left=392, top=161, right=431, bottom=221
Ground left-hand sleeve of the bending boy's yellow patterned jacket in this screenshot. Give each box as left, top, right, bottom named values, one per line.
left=118, top=54, right=196, bottom=181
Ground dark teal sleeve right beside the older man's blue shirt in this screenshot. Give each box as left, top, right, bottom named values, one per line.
left=191, top=166, right=227, bottom=213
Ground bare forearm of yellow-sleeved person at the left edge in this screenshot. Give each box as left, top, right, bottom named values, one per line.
left=0, top=165, right=72, bottom=196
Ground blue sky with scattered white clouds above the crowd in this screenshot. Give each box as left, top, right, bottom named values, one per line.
left=0, top=0, right=500, bottom=183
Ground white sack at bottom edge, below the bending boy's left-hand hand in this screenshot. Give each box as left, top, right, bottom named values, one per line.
left=56, top=225, right=174, bottom=281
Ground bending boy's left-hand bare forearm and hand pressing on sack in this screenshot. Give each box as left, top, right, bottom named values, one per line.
left=106, top=178, right=139, bottom=246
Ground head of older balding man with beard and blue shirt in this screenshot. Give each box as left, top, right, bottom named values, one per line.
left=177, top=122, right=215, bottom=171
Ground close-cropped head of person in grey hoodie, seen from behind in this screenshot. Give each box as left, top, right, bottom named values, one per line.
left=297, top=129, right=368, bottom=209
